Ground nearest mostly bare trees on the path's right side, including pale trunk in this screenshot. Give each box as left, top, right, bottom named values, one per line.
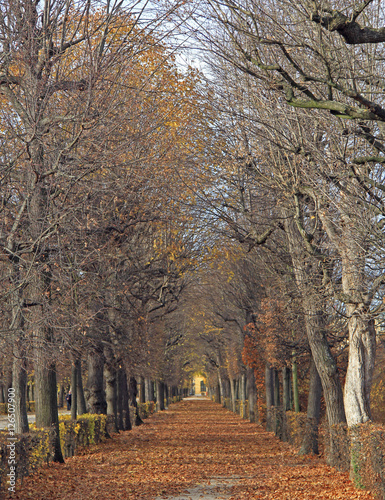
left=175, top=0, right=385, bottom=472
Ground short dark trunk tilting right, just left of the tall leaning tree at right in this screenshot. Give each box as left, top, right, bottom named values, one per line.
left=299, top=358, right=322, bottom=455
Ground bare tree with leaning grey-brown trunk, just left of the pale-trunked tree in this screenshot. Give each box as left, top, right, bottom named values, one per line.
left=176, top=44, right=352, bottom=454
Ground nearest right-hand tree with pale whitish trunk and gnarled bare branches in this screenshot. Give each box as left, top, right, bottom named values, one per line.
left=200, top=1, right=384, bottom=434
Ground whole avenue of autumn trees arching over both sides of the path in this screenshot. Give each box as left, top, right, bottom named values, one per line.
left=0, top=0, right=385, bottom=484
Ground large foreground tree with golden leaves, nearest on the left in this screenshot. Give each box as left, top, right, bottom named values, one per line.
left=0, top=1, right=195, bottom=461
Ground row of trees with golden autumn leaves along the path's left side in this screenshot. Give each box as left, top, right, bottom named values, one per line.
left=0, top=0, right=213, bottom=460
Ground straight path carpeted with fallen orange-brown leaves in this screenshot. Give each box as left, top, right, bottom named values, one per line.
left=7, top=400, right=373, bottom=500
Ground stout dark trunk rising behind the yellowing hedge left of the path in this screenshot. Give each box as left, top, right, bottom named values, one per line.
left=85, top=348, right=107, bottom=414
